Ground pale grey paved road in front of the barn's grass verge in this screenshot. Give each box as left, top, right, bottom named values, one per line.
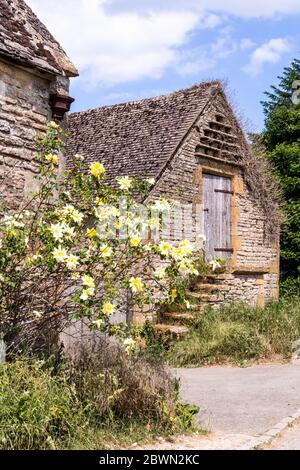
left=175, top=362, right=300, bottom=437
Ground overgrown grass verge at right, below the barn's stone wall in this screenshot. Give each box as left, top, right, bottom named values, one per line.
left=162, top=297, right=300, bottom=367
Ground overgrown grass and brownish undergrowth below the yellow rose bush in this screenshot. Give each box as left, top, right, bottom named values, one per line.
left=0, top=343, right=198, bottom=449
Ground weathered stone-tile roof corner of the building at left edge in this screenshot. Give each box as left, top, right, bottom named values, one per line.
left=0, top=0, right=78, bottom=77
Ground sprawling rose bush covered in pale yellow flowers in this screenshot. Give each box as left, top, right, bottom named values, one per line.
left=0, top=125, right=203, bottom=351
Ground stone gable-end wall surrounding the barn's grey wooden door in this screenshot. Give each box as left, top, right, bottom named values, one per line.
left=151, top=91, right=279, bottom=305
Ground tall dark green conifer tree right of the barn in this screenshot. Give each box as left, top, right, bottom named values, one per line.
left=262, top=59, right=300, bottom=288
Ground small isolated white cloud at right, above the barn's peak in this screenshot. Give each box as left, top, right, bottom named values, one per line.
left=243, top=38, right=291, bottom=76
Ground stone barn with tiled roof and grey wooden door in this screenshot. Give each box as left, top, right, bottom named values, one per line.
left=67, top=82, right=279, bottom=305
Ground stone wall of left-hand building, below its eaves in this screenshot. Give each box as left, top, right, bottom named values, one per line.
left=0, top=59, right=68, bottom=206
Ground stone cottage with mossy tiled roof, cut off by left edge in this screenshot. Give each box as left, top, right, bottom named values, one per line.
left=0, top=0, right=78, bottom=205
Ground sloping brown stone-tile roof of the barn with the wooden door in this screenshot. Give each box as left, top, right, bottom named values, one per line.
left=67, top=82, right=220, bottom=183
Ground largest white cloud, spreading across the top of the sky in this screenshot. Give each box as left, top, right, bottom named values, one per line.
left=26, top=0, right=300, bottom=88
